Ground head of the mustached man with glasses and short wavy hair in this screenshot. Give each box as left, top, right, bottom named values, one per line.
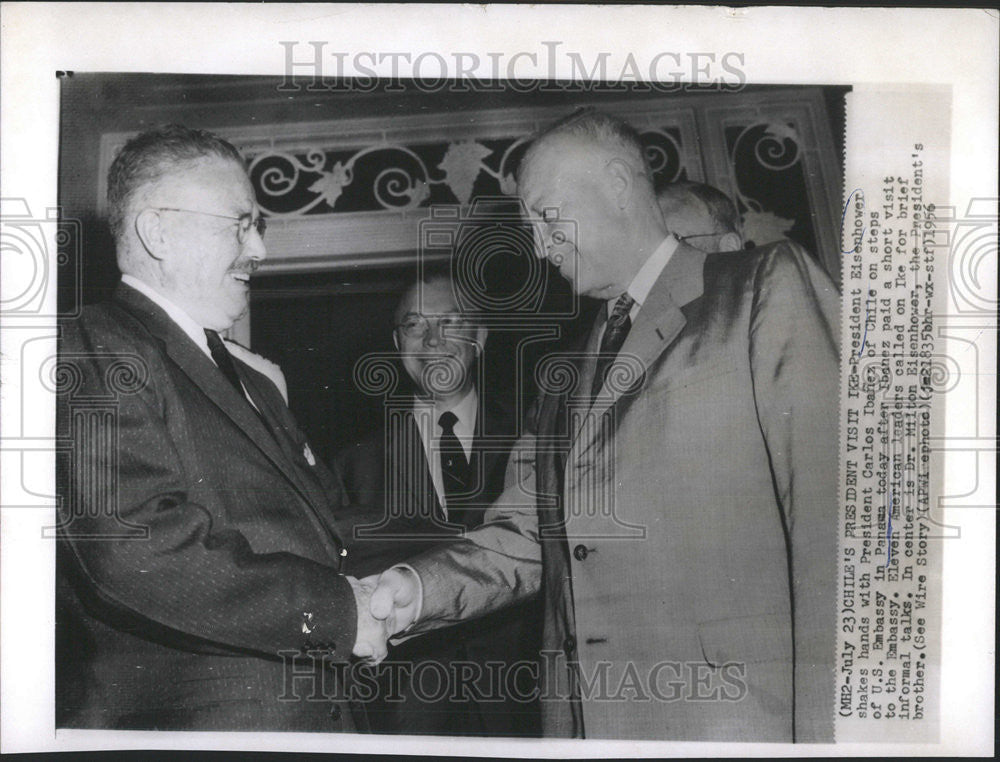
left=108, top=125, right=267, bottom=331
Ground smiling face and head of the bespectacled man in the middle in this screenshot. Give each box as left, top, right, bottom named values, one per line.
left=393, top=274, right=487, bottom=402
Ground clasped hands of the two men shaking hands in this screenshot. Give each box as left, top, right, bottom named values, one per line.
left=347, top=567, right=421, bottom=664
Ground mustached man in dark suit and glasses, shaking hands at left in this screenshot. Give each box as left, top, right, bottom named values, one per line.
left=56, top=125, right=382, bottom=731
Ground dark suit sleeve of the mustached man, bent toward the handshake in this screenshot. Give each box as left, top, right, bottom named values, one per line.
left=59, top=320, right=357, bottom=659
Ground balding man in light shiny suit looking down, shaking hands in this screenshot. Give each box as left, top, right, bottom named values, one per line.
left=364, top=112, right=839, bottom=741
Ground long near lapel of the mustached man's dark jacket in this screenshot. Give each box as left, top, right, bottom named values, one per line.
left=115, top=284, right=322, bottom=507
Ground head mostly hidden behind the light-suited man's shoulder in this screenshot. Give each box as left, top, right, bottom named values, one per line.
left=657, top=181, right=743, bottom=254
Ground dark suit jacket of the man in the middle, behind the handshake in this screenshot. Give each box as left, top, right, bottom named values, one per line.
left=336, top=395, right=540, bottom=736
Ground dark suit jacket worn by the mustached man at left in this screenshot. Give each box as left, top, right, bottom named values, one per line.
left=56, top=284, right=364, bottom=731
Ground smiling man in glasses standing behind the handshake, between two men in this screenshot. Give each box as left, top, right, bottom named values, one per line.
left=337, top=273, right=540, bottom=736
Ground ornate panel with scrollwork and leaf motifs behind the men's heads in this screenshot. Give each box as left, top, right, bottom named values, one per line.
left=98, top=88, right=841, bottom=278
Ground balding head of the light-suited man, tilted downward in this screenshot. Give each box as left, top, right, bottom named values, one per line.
left=517, top=110, right=666, bottom=299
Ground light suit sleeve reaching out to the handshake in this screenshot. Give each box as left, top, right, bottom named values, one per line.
left=407, top=406, right=541, bottom=634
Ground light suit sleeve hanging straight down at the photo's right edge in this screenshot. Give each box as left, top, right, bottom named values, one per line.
left=750, top=243, right=840, bottom=741
